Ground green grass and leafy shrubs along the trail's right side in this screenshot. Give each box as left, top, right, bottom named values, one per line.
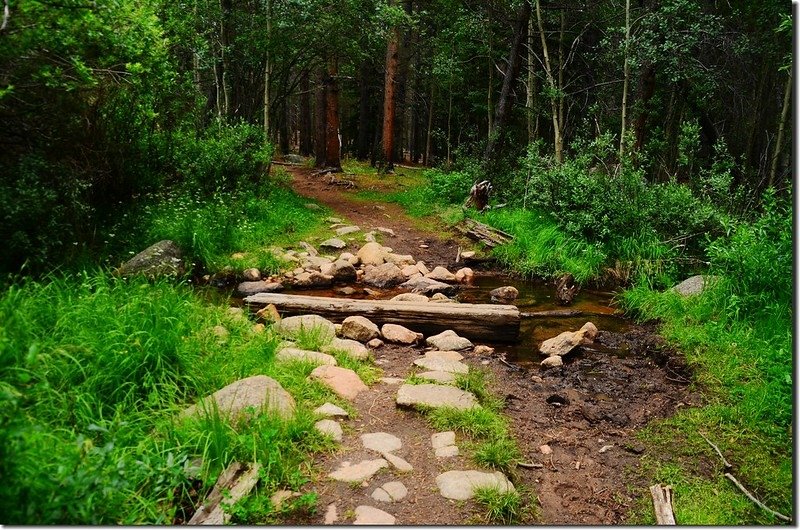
left=360, top=145, right=793, bottom=524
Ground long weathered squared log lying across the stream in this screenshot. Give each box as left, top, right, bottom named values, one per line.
left=244, top=293, right=520, bottom=342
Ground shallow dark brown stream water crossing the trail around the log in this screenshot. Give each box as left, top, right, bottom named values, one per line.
left=222, top=274, right=632, bottom=368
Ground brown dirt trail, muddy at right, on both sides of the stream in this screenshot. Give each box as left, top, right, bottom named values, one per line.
left=290, top=163, right=699, bottom=525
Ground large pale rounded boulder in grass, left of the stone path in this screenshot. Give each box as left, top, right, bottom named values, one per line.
left=183, top=375, right=295, bottom=418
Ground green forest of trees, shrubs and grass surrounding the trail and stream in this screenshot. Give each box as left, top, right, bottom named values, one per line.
left=0, top=0, right=795, bottom=525
